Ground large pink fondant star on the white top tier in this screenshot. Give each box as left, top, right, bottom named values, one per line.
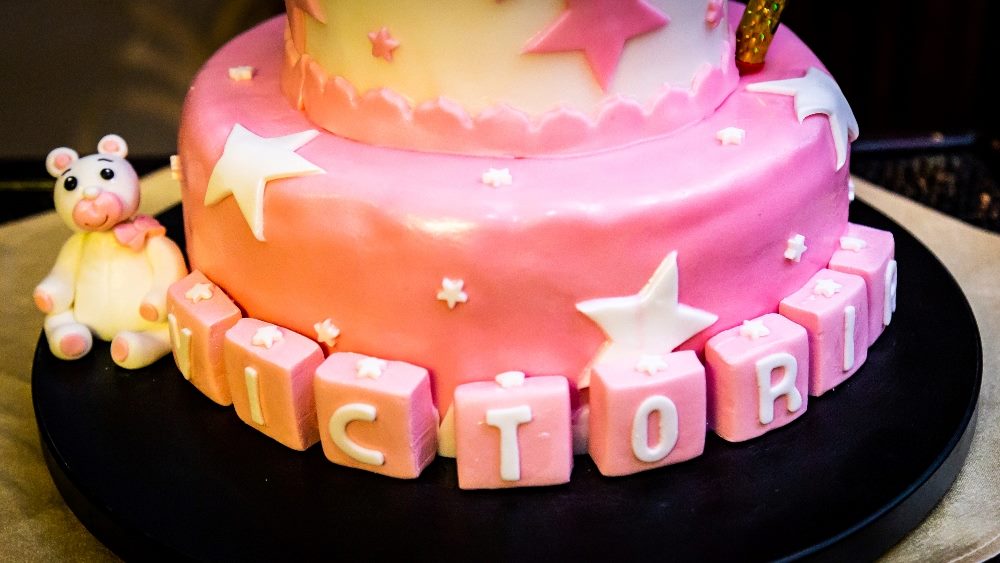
left=524, top=0, right=670, bottom=90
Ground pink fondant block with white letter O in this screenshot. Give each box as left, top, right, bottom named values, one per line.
left=589, top=350, right=706, bottom=476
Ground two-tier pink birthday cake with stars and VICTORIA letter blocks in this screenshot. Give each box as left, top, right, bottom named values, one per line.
left=167, top=0, right=895, bottom=488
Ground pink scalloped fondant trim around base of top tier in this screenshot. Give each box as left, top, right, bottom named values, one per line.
left=281, top=29, right=739, bottom=156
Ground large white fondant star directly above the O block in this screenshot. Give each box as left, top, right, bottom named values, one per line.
left=576, top=251, right=719, bottom=355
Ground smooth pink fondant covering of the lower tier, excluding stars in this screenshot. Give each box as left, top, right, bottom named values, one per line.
left=179, top=14, right=848, bottom=418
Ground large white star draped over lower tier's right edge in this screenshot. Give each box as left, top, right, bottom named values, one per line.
left=747, top=67, right=859, bottom=170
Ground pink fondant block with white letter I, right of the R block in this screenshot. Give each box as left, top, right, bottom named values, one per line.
left=778, top=270, right=868, bottom=397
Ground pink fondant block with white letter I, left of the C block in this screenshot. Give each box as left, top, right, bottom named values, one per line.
left=224, top=319, right=323, bottom=450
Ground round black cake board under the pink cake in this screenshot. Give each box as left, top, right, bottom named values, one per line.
left=32, top=202, right=982, bottom=561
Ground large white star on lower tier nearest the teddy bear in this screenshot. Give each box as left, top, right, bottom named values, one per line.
left=205, top=123, right=325, bottom=241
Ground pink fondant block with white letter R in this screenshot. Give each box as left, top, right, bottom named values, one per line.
left=705, top=313, right=809, bottom=442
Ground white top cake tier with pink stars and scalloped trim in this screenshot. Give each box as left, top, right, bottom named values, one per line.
left=282, top=0, right=739, bottom=156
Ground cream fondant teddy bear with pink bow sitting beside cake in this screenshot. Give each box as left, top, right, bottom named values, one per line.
left=34, top=135, right=187, bottom=369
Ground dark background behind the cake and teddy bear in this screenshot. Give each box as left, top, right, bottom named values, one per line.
left=0, top=0, right=1000, bottom=229
